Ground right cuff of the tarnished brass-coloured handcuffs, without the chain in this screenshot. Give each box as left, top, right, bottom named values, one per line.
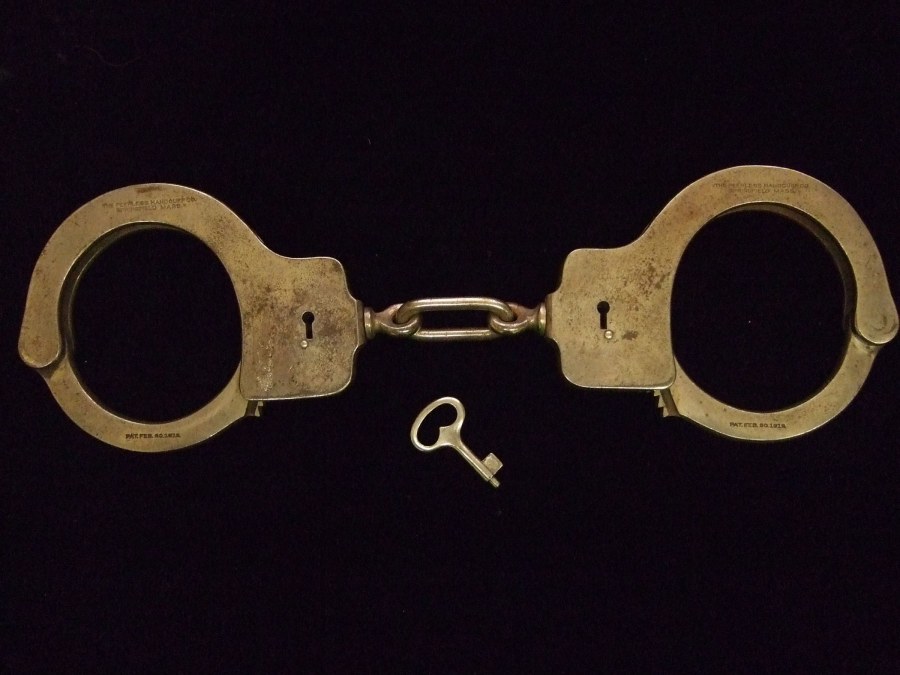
left=547, top=166, right=898, bottom=441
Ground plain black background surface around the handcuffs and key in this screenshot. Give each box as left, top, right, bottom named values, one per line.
left=0, top=3, right=900, bottom=673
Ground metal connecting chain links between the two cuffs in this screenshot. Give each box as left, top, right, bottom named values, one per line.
left=363, top=297, right=547, bottom=341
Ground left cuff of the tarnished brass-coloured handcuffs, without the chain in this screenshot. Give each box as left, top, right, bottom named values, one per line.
left=19, top=184, right=364, bottom=452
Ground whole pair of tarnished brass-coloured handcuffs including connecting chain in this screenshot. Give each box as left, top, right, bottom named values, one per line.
left=19, top=166, right=898, bottom=452
